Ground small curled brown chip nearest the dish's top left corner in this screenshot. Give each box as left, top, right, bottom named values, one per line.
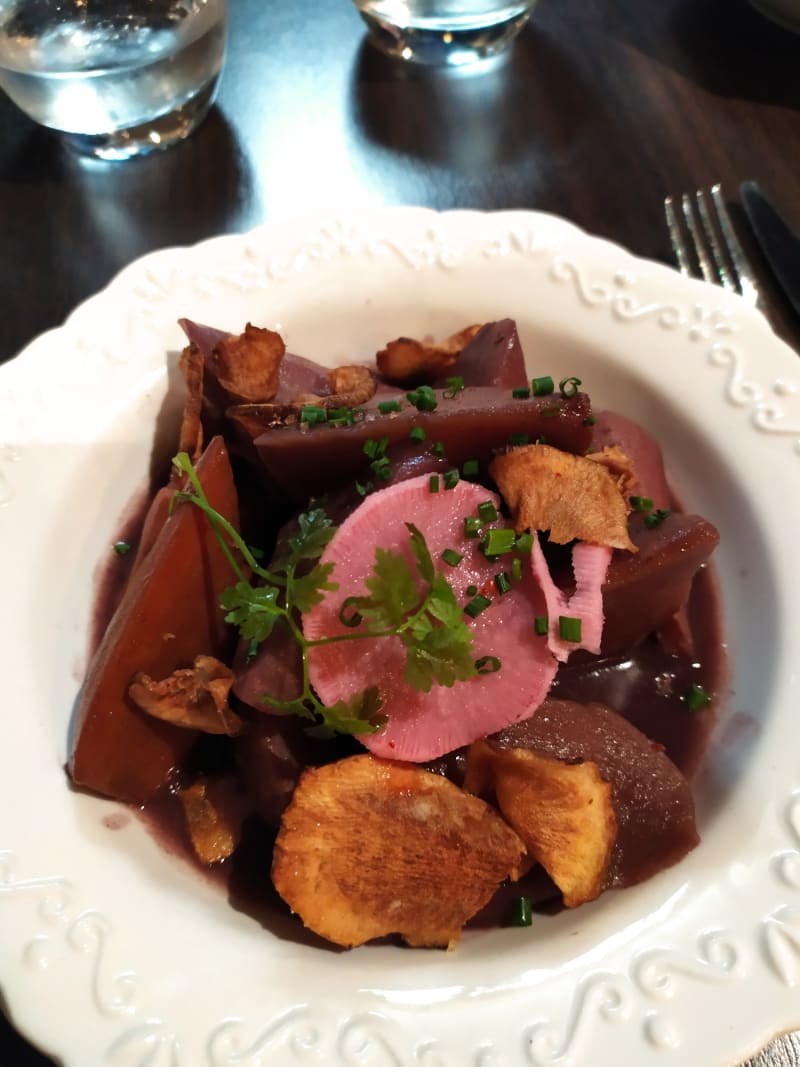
left=207, top=322, right=286, bottom=403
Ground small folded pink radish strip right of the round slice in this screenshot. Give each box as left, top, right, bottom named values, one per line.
left=530, top=535, right=611, bottom=663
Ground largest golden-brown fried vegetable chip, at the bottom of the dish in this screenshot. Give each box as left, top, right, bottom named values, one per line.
left=272, top=755, right=525, bottom=947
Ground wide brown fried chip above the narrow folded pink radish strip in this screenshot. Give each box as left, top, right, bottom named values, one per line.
left=489, top=445, right=636, bottom=552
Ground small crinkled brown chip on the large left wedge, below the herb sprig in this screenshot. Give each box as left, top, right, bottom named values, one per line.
left=128, top=656, right=242, bottom=737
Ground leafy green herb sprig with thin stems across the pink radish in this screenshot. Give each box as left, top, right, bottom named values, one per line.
left=171, top=454, right=477, bottom=737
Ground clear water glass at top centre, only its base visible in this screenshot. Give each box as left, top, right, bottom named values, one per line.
left=354, top=0, right=537, bottom=66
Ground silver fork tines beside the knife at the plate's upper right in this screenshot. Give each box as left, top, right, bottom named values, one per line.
left=663, top=185, right=764, bottom=312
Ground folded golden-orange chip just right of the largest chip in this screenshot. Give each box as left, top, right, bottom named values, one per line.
left=464, top=740, right=617, bottom=908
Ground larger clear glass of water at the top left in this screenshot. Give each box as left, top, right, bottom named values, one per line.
left=0, top=0, right=227, bottom=159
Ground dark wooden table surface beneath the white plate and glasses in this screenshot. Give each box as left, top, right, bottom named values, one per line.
left=0, top=0, right=800, bottom=1067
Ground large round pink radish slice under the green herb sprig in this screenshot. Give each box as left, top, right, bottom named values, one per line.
left=303, top=475, right=558, bottom=762
